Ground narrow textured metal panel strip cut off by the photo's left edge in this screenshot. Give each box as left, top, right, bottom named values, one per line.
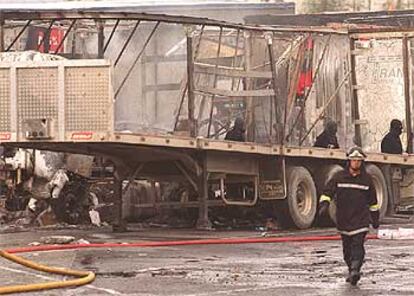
left=0, top=69, right=11, bottom=132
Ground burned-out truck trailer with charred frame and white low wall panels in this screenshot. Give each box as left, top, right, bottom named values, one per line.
left=0, top=11, right=414, bottom=228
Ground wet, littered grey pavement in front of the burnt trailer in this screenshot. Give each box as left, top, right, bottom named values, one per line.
left=0, top=225, right=414, bottom=296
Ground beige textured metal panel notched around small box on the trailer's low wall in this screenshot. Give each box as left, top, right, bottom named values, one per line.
left=17, top=67, right=58, bottom=131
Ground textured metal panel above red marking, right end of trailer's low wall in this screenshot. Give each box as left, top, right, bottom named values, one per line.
left=65, top=67, right=111, bottom=131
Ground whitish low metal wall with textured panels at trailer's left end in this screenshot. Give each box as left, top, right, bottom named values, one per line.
left=0, top=60, right=114, bottom=142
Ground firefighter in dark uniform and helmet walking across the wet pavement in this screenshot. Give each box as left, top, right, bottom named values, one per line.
left=319, top=147, right=379, bottom=286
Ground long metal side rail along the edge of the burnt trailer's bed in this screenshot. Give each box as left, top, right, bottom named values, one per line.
left=9, top=133, right=414, bottom=166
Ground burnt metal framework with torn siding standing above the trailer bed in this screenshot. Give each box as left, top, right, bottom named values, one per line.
left=0, top=10, right=412, bottom=157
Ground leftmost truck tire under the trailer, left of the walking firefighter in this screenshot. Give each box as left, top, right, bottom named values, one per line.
left=275, top=166, right=317, bottom=229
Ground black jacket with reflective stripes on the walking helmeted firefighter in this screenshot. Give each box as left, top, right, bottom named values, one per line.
left=321, top=168, right=379, bottom=235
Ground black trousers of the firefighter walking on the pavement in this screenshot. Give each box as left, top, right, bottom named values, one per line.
left=341, top=232, right=367, bottom=271
